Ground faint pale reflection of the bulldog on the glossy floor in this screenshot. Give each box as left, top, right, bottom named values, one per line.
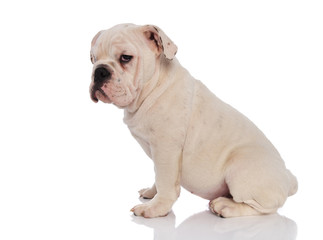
left=133, top=211, right=297, bottom=240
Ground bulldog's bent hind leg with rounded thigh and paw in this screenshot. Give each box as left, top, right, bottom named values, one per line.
left=210, top=151, right=290, bottom=217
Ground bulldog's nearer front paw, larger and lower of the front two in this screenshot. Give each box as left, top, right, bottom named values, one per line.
left=130, top=199, right=172, bottom=218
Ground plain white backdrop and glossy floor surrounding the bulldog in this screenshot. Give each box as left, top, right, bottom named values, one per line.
left=0, top=0, right=323, bottom=240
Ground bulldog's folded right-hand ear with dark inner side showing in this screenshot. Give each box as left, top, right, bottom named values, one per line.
left=142, top=25, right=177, bottom=60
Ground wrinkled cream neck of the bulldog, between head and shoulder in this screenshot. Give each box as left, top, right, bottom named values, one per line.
left=124, top=56, right=183, bottom=125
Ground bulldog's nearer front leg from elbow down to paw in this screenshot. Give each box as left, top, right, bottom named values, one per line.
left=131, top=150, right=181, bottom=218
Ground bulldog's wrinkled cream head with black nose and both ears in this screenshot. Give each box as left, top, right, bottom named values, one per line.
left=90, top=24, right=177, bottom=108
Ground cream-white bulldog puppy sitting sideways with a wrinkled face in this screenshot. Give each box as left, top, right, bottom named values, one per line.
left=90, top=24, right=297, bottom=218
